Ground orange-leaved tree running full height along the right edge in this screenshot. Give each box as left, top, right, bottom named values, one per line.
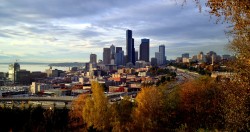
left=184, top=0, right=250, bottom=130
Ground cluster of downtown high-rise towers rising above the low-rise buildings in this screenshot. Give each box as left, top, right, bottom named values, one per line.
left=86, top=30, right=166, bottom=68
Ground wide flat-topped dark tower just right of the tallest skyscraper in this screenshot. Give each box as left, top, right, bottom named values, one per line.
left=140, top=39, right=150, bottom=62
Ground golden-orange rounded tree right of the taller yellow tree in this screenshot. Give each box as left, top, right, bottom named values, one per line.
left=133, top=87, right=165, bottom=131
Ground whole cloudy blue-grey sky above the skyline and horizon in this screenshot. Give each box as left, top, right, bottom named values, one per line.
left=0, top=0, right=230, bottom=63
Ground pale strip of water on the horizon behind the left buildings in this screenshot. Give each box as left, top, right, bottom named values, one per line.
left=0, top=63, right=69, bottom=72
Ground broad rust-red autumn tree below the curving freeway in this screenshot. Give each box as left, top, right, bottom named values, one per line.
left=179, top=77, right=224, bottom=131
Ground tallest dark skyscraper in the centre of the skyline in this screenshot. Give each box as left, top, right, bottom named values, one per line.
left=126, top=30, right=134, bottom=64
